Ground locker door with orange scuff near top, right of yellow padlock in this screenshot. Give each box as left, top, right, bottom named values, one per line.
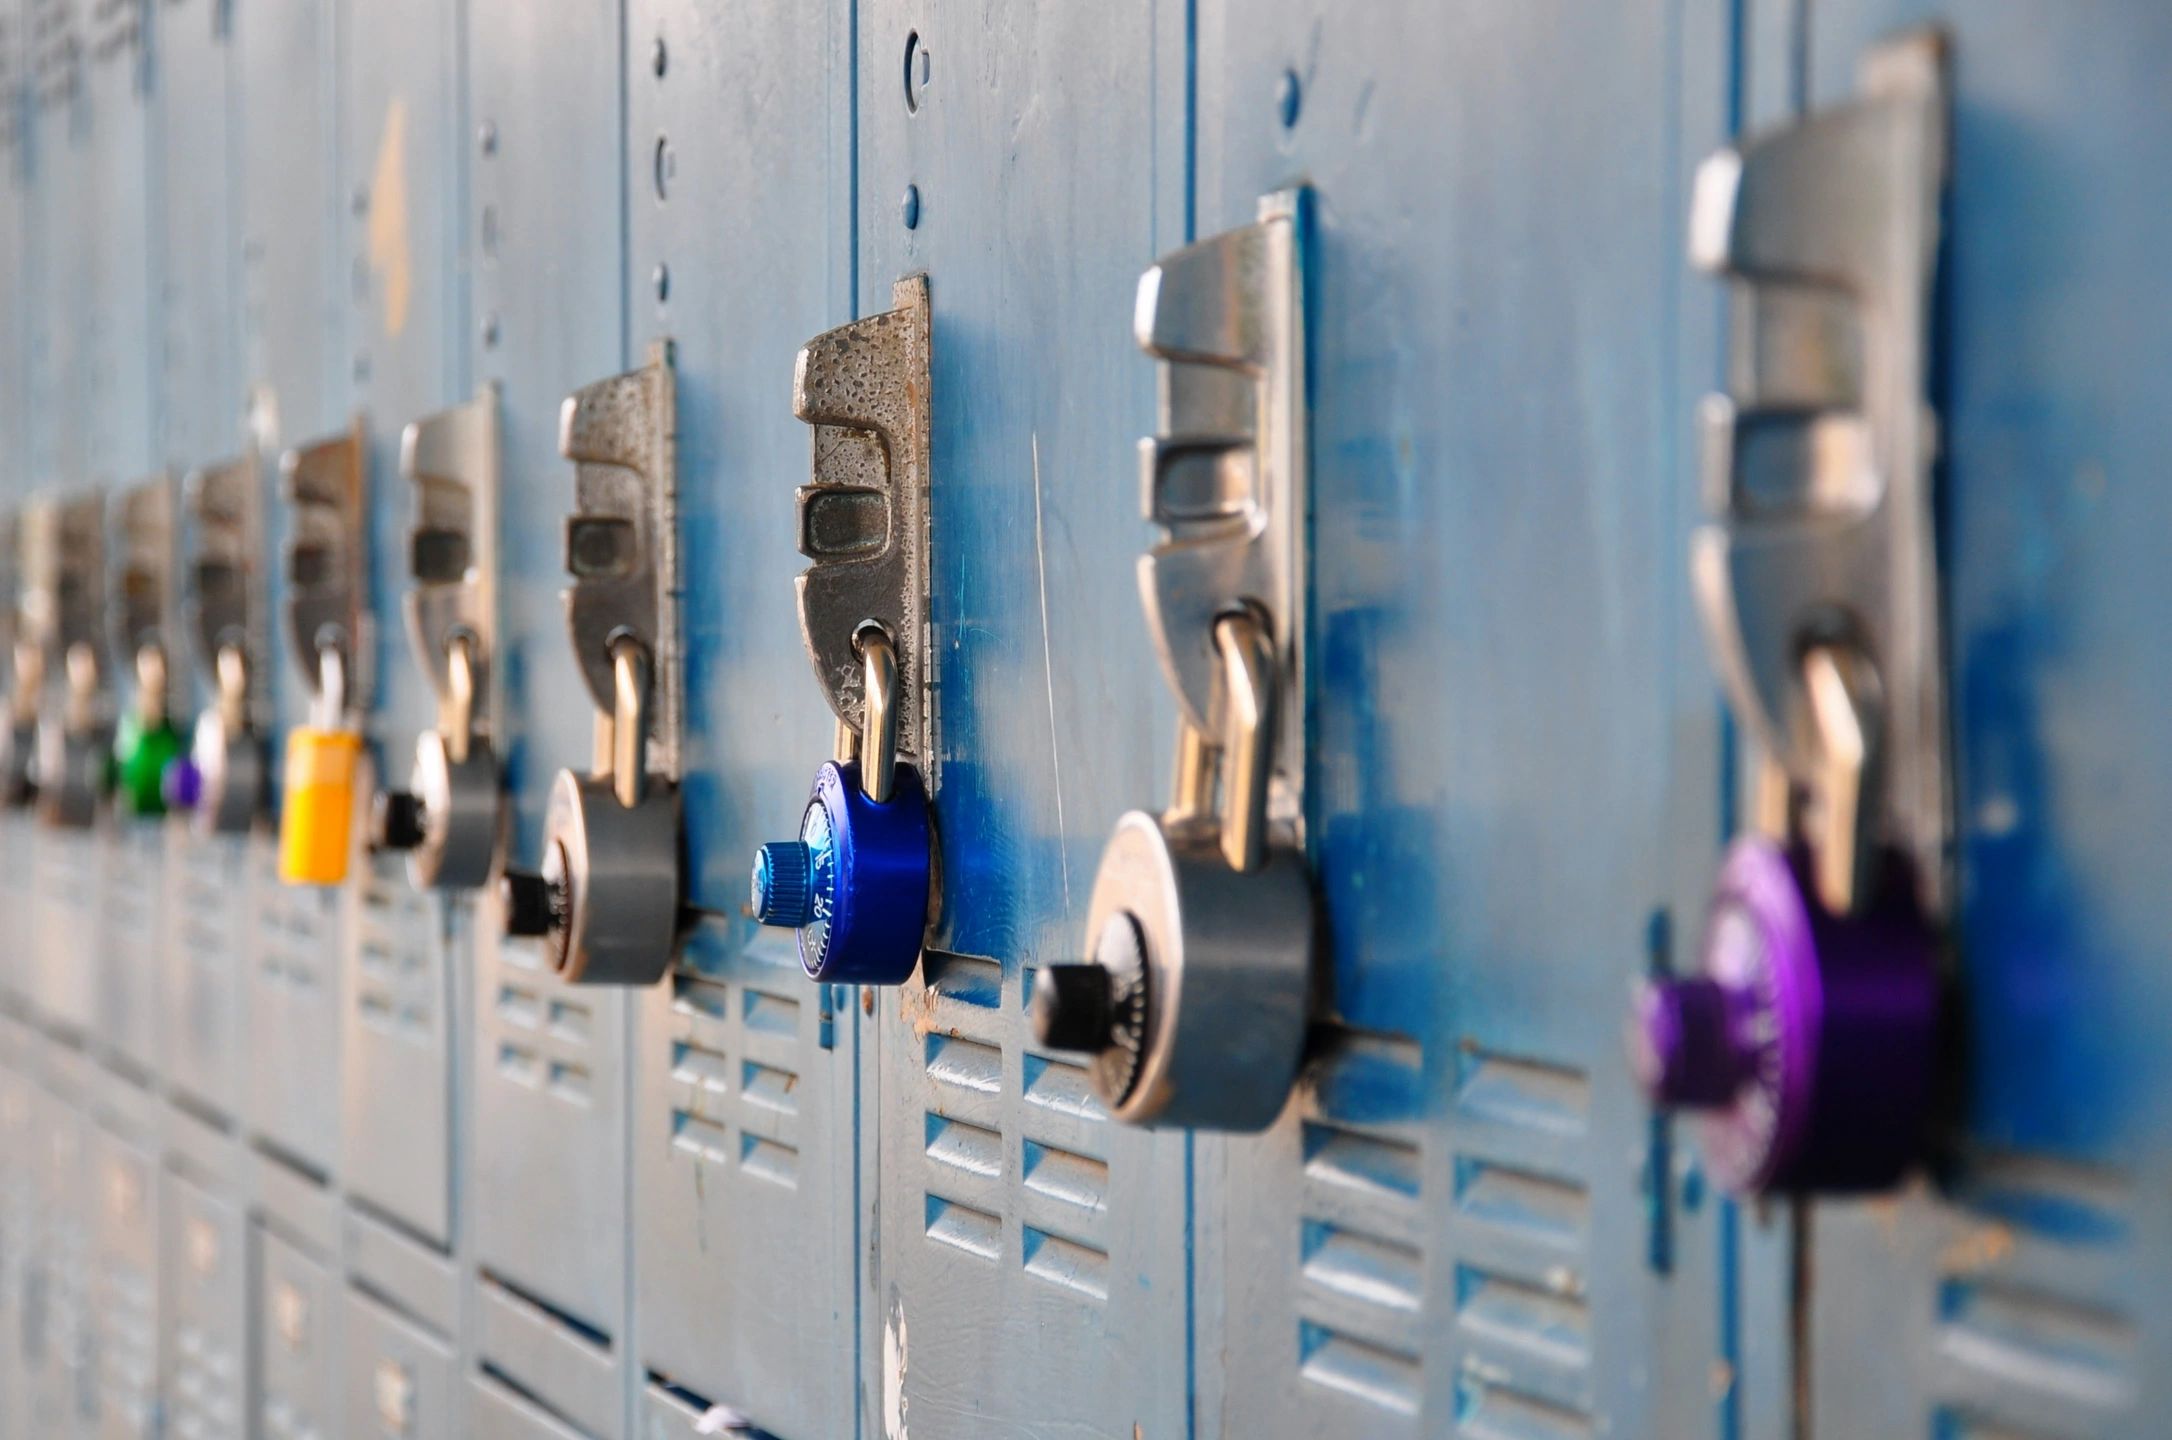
left=341, top=2, right=469, bottom=1247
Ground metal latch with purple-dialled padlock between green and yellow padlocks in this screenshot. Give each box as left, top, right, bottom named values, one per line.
left=165, top=450, right=272, bottom=834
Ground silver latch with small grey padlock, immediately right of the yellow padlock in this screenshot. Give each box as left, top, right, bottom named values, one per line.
left=369, top=384, right=504, bottom=890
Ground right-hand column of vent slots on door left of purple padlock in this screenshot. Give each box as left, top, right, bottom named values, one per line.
left=1449, top=1040, right=1596, bottom=1440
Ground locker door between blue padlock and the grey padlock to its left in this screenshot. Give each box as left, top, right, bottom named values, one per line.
left=621, top=0, right=867, bottom=1438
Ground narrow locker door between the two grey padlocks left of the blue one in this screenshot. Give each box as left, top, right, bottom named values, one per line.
left=467, top=0, right=632, bottom=1390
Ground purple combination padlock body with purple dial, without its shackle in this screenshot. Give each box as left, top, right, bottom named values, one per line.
left=1631, top=838, right=1940, bottom=1192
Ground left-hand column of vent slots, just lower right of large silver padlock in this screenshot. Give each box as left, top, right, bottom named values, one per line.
left=1297, top=1027, right=1425, bottom=1416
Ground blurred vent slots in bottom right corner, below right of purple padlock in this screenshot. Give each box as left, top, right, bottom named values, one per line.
left=1931, top=1155, right=2139, bottom=1440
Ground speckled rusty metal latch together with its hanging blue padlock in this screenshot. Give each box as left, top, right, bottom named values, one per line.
left=752, top=276, right=934, bottom=984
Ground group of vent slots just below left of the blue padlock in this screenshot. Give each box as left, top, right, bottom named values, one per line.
left=664, top=936, right=804, bottom=1188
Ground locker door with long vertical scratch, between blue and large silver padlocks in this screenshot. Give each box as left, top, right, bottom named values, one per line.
left=858, top=0, right=1192, bottom=1436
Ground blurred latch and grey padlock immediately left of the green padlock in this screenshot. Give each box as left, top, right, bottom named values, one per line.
left=26, top=491, right=113, bottom=830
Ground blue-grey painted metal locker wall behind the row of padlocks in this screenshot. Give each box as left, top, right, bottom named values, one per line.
left=0, top=0, right=2172, bottom=1440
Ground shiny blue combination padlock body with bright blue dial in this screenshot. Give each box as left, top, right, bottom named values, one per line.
left=754, top=760, right=934, bottom=984
